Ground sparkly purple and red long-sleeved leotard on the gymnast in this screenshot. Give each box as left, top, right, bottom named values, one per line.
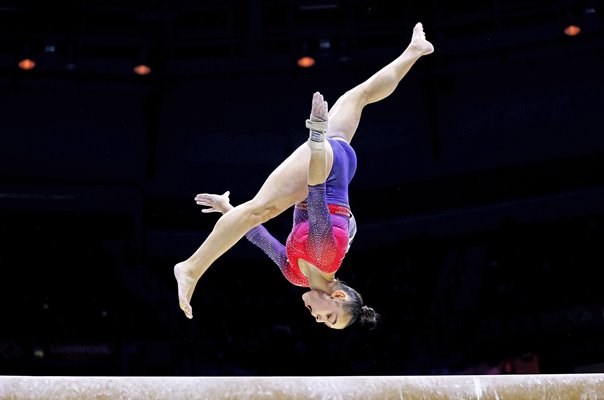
left=246, top=138, right=357, bottom=287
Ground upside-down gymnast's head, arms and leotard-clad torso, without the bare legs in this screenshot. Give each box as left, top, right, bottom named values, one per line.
left=195, top=92, right=366, bottom=329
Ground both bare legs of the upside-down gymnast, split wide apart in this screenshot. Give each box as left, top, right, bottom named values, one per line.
left=174, top=24, right=434, bottom=318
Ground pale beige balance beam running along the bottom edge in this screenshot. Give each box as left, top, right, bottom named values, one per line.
left=0, top=374, right=604, bottom=400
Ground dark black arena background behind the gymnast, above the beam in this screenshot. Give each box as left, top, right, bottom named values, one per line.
left=0, top=0, right=604, bottom=376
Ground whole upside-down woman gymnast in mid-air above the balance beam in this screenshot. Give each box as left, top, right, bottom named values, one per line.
left=174, top=23, right=434, bottom=329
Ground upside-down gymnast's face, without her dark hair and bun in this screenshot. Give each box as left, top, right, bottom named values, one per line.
left=302, top=289, right=351, bottom=329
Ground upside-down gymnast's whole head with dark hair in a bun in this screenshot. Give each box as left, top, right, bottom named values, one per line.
left=302, top=281, right=380, bottom=329
